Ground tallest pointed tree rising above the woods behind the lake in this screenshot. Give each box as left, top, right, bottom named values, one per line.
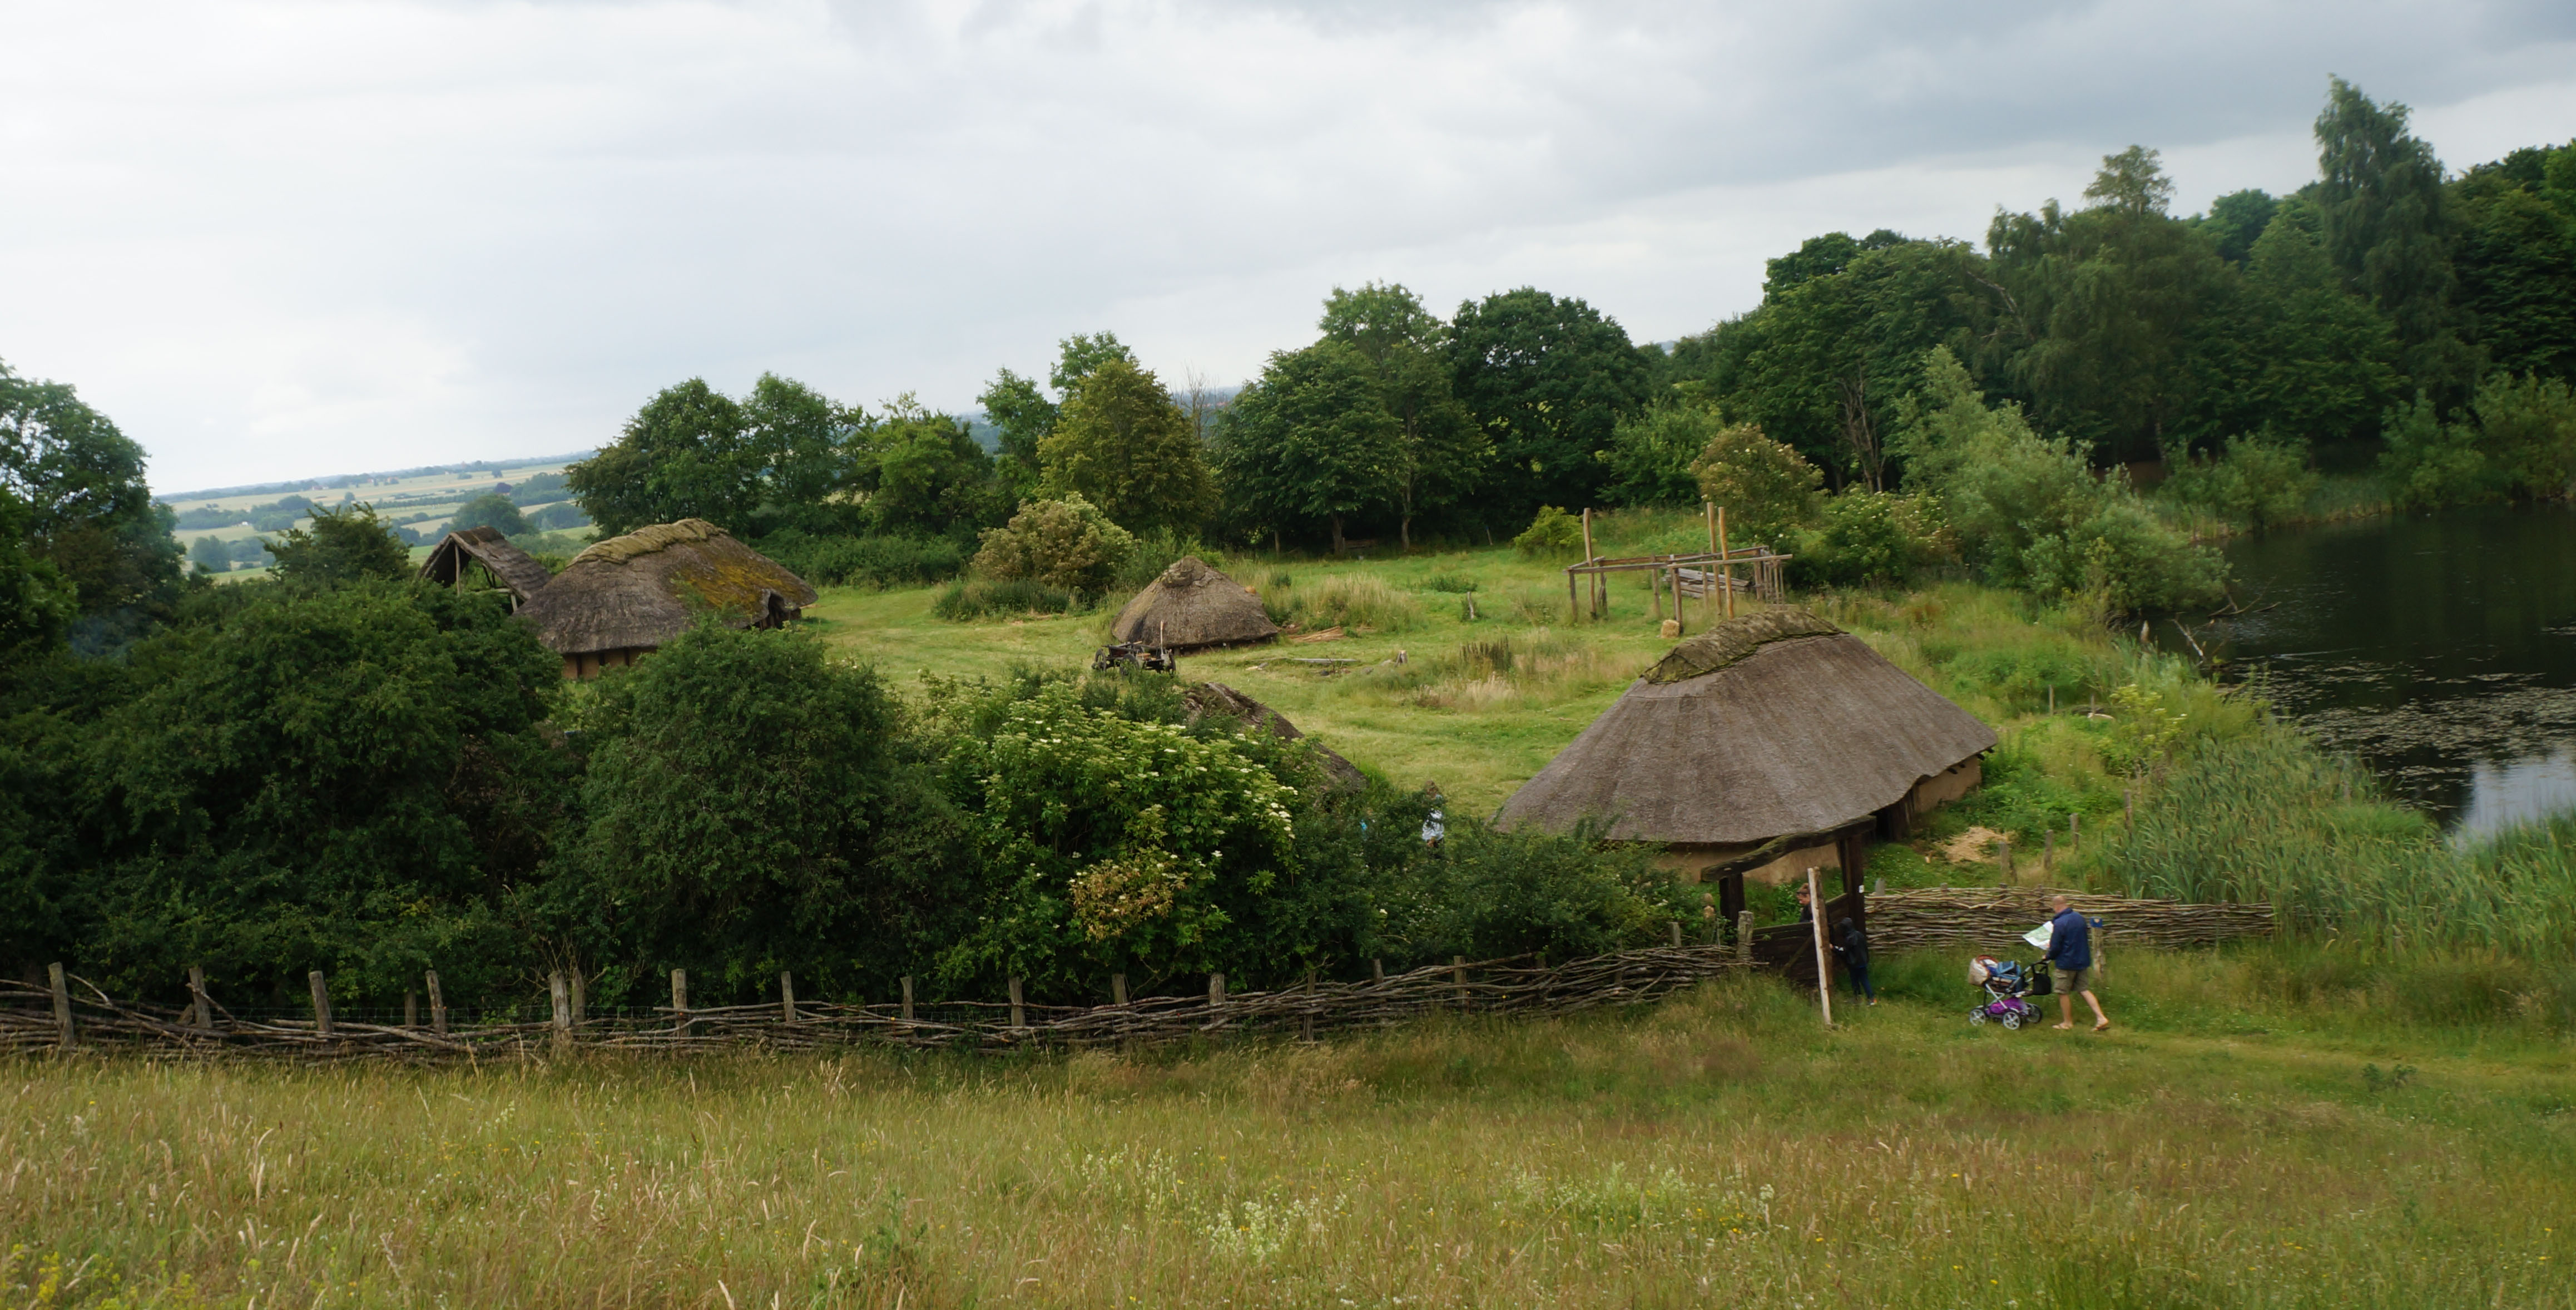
left=2316, top=77, right=2475, bottom=394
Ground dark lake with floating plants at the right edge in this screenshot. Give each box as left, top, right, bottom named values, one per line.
left=2200, top=508, right=2576, bottom=836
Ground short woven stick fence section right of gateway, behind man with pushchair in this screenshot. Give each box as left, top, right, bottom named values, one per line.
left=1867, top=887, right=2272, bottom=954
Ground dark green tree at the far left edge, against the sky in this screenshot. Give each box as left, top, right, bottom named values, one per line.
left=0, top=364, right=180, bottom=650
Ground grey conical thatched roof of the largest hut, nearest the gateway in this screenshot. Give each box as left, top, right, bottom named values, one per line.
left=1497, top=609, right=1994, bottom=846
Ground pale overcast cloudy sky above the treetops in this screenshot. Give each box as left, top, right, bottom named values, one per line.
left=0, top=0, right=2576, bottom=490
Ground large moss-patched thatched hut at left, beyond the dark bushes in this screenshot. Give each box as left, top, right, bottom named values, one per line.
left=521, top=518, right=814, bottom=678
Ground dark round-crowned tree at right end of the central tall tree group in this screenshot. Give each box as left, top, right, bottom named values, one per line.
left=1448, top=286, right=1651, bottom=523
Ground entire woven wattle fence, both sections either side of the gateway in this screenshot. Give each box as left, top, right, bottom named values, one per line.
left=0, top=887, right=2272, bottom=1060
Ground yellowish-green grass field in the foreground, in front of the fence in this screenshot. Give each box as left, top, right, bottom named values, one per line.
left=0, top=954, right=2576, bottom=1310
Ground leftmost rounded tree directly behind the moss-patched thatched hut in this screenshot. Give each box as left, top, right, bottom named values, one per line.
left=564, top=377, right=760, bottom=536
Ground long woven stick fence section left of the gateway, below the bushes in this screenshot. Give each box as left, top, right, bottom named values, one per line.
left=0, top=946, right=1752, bottom=1060
